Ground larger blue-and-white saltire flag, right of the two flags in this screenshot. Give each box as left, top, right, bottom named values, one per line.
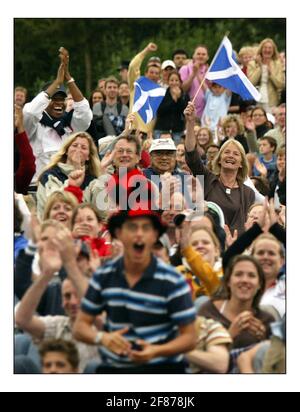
left=206, top=36, right=261, bottom=102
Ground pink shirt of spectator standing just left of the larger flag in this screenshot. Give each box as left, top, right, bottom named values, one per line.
left=179, top=62, right=208, bottom=118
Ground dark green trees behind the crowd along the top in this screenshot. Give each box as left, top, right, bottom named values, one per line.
left=14, top=18, right=286, bottom=98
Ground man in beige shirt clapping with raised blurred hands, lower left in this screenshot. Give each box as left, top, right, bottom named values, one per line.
left=16, top=221, right=99, bottom=372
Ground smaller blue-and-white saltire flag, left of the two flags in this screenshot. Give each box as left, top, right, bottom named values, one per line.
left=132, top=76, right=166, bottom=124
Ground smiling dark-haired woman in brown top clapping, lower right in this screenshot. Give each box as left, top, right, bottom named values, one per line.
left=199, top=256, right=274, bottom=349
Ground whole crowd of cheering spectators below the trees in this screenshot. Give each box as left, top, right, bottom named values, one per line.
left=14, top=38, right=286, bottom=374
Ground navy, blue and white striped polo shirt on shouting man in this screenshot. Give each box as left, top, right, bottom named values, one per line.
left=81, top=257, right=196, bottom=367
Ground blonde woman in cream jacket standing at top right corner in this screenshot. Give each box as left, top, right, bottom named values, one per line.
left=247, top=38, right=285, bottom=111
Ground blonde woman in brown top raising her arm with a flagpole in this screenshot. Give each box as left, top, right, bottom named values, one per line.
left=184, top=102, right=255, bottom=234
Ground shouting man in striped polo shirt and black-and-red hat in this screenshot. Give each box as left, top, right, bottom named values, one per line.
left=74, top=203, right=196, bottom=373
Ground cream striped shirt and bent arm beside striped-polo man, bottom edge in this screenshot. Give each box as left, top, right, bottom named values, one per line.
left=186, top=316, right=232, bottom=373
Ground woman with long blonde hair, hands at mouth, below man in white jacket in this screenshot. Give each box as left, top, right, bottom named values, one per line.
left=37, top=132, right=102, bottom=217
